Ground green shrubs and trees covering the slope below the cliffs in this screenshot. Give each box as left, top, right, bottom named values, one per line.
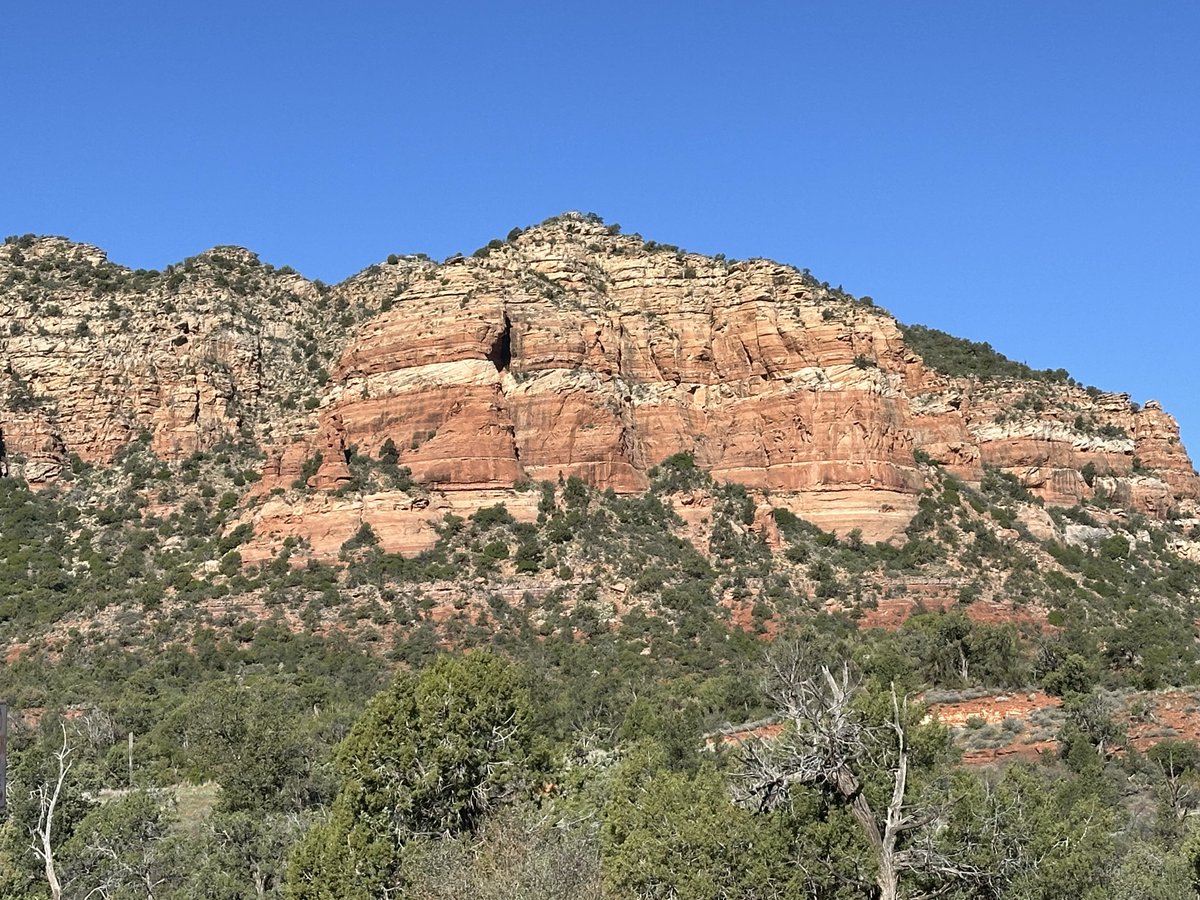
left=0, top=445, right=1200, bottom=898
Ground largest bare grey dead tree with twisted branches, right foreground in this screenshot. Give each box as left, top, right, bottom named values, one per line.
left=739, top=647, right=982, bottom=900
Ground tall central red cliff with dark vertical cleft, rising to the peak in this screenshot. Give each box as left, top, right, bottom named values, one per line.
left=302, top=217, right=923, bottom=536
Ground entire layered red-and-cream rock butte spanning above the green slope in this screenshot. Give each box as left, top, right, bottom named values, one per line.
left=0, top=214, right=1200, bottom=556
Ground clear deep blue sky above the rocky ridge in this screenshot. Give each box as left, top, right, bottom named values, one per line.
left=0, top=0, right=1200, bottom=448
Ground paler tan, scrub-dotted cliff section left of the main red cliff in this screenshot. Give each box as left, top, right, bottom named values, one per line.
left=0, top=238, right=427, bottom=485
